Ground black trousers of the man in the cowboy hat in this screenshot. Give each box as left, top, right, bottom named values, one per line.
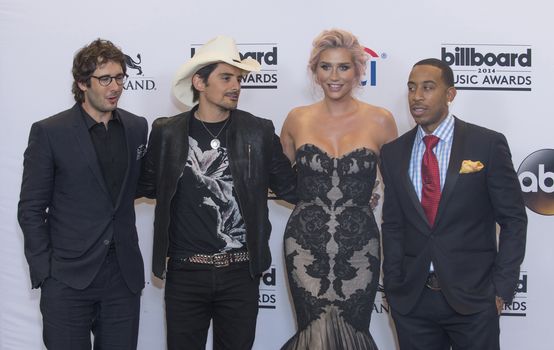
left=165, top=259, right=260, bottom=350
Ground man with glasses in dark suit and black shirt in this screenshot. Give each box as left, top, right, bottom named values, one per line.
left=18, top=39, right=148, bottom=350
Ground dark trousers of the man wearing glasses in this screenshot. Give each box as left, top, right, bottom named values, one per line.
left=40, top=249, right=140, bottom=350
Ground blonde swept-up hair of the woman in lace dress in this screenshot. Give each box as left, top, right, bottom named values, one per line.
left=308, top=29, right=369, bottom=85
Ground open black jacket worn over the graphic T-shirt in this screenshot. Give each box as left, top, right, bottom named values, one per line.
left=139, top=107, right=296, bottom=279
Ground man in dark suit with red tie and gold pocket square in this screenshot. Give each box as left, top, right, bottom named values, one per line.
left=381, top=59, right=527, bottom=350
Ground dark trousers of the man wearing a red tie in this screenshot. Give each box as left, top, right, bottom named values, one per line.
left=391, top=288, right=500, bottom=350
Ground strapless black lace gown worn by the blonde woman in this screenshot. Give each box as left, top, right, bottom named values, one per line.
left=282, top=144, right=380, bottom=350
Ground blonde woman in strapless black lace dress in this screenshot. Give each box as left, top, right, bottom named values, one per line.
left=281, top=29, right=397, bottom=350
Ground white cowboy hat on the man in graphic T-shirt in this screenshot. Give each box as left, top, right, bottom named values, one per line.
left=173, top=35, right=261, bottom=107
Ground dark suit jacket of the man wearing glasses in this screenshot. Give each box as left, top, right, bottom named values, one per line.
left=18, top=104, right=148, bottom=292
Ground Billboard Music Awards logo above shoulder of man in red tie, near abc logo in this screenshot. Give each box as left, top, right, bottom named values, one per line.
left=441, top=44, right=533, bottom=91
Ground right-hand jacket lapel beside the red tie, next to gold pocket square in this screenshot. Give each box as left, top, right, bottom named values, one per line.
left=435, top=118, right=466, bottom=226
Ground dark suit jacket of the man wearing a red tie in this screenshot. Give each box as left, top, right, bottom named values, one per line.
left=381, top=119, right=527, bottom=314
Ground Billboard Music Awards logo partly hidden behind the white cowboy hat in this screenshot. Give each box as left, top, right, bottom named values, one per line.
left=190, top=43, right=279, bottom=89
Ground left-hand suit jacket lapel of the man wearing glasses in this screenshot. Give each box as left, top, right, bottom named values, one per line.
left=72, top=104, right=111, bottom=198
